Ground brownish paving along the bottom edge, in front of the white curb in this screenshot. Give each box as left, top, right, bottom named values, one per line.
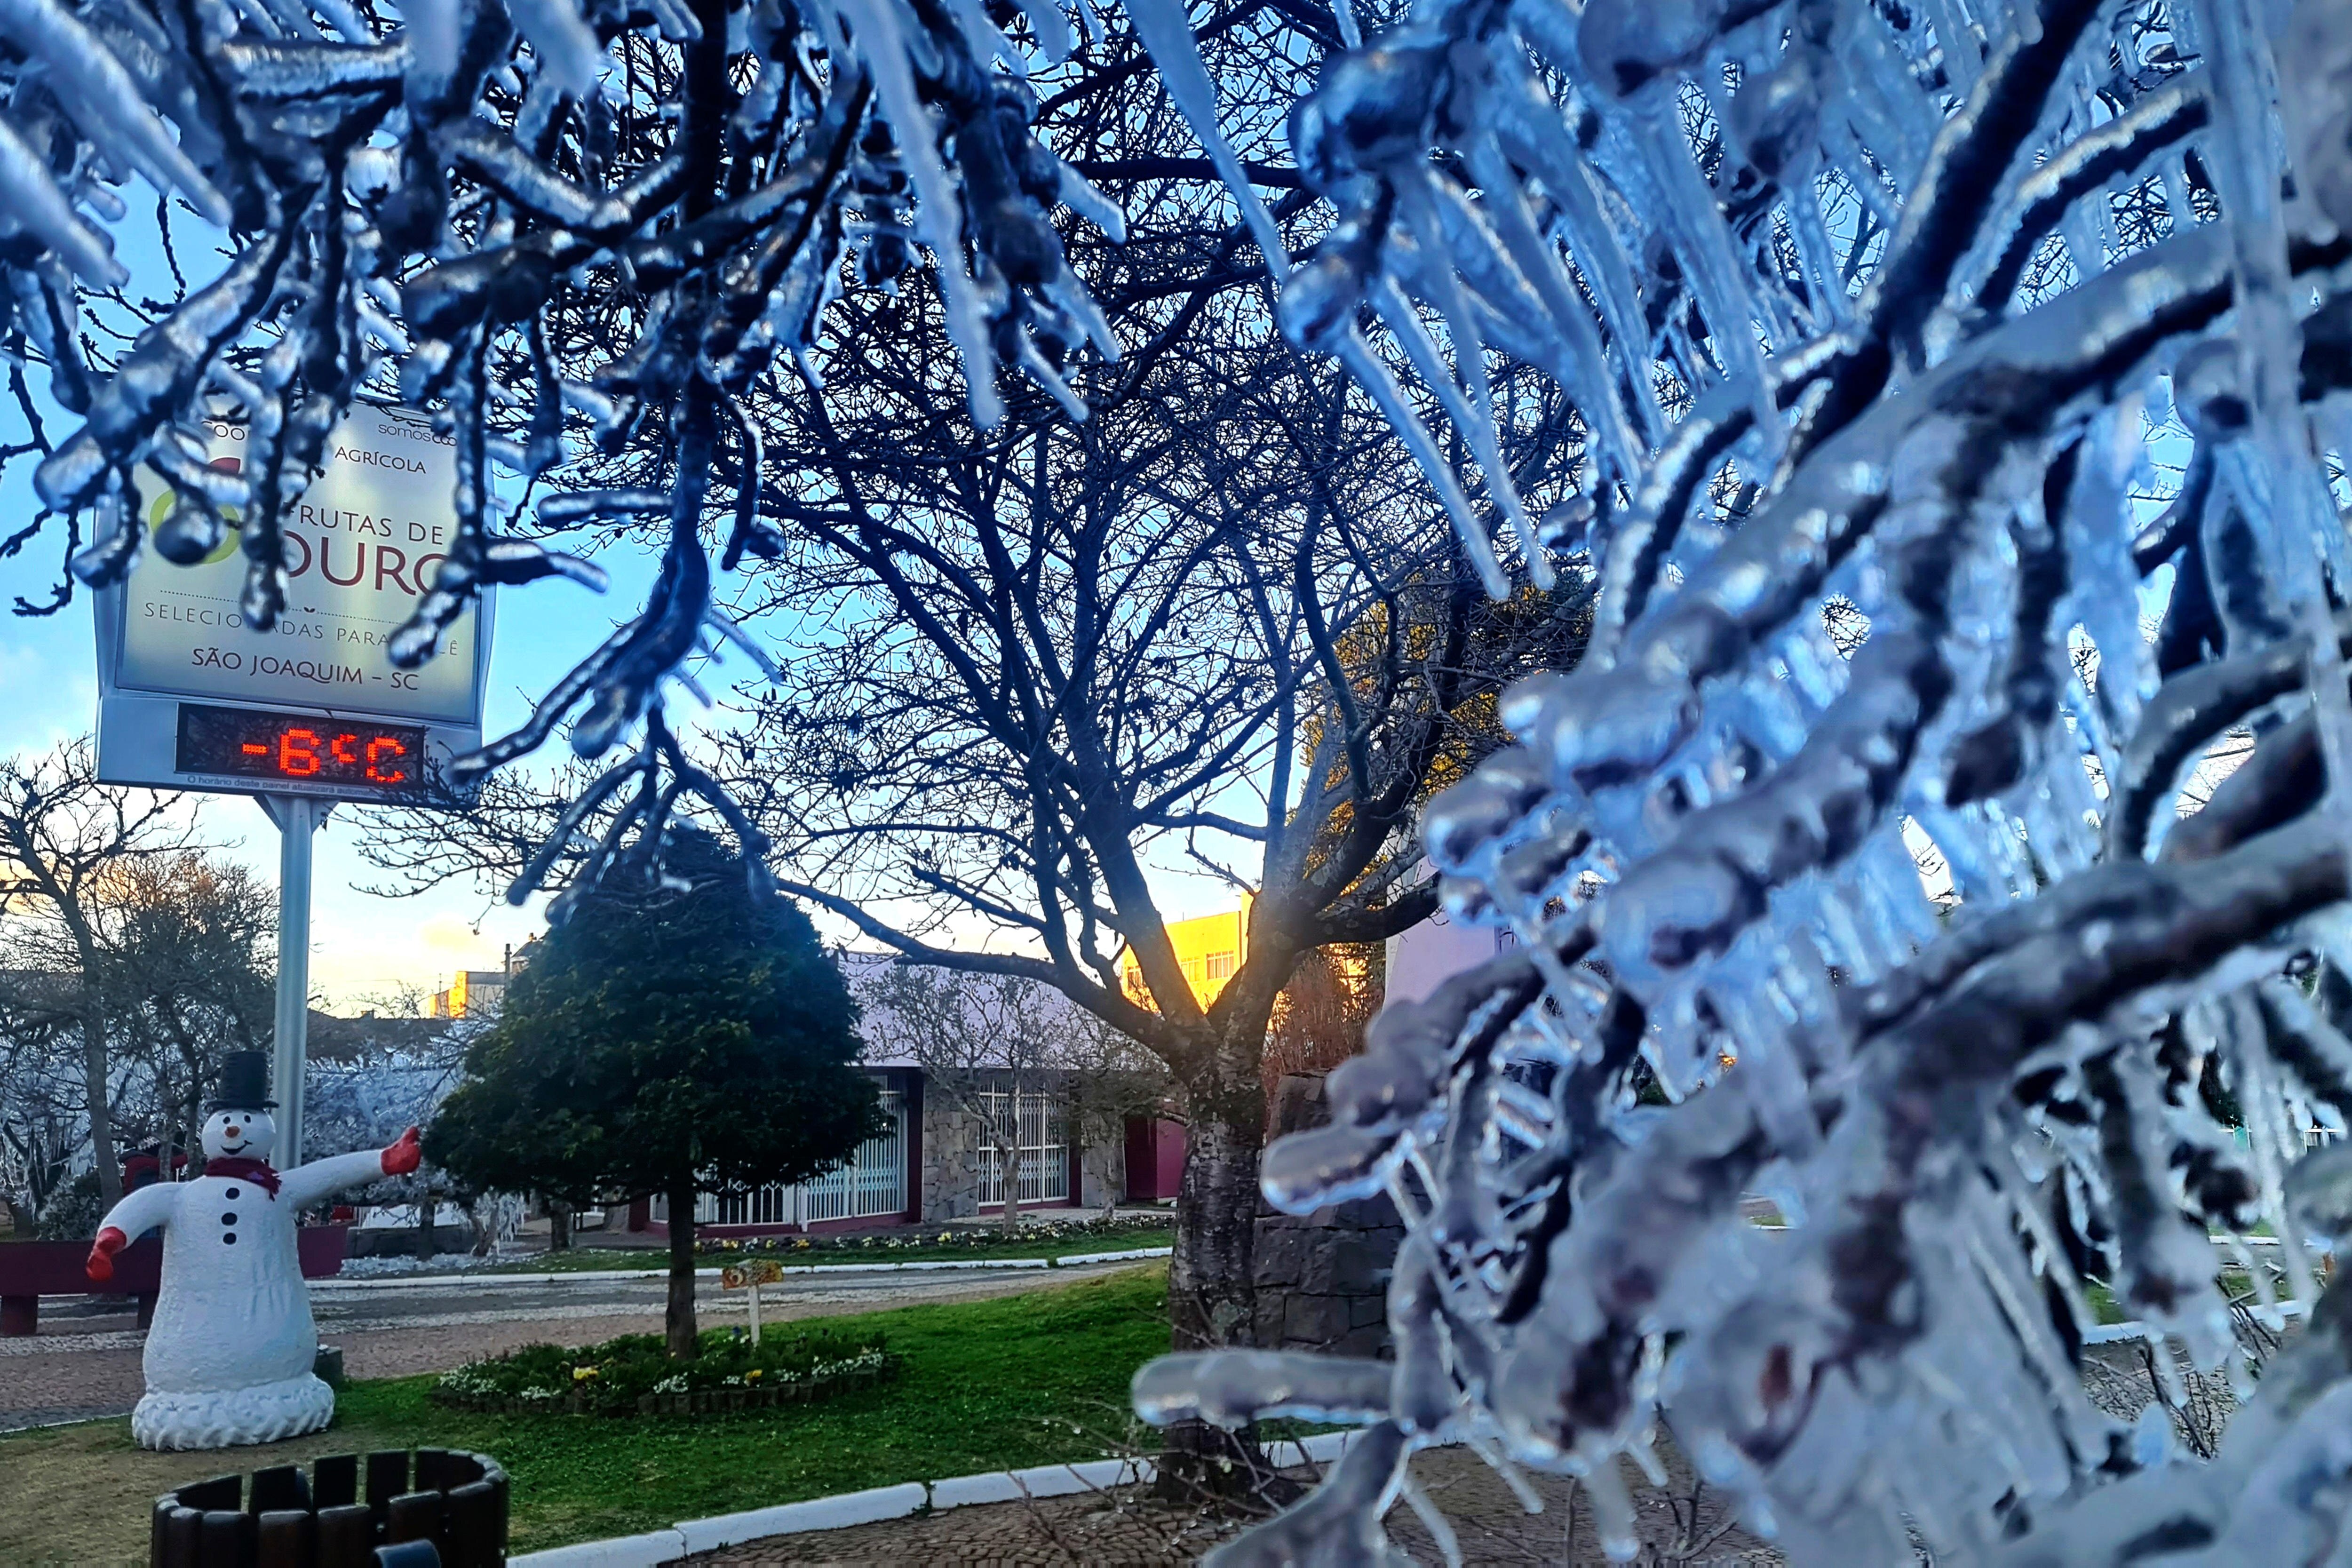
left=687, top=1446, right=1783, bottom=1568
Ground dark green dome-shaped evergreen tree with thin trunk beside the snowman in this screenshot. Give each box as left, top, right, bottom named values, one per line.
left=426, top=828, right=880, bottom=1356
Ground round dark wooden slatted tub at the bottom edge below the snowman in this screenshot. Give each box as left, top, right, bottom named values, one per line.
left=148, top=1448, right=508, bottom=1568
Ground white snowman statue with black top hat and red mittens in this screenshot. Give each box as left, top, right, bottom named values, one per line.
left=89, top=1051, right=421, bottom=1448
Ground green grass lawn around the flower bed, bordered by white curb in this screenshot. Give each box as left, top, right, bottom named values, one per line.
left=0, top=1265, right=1169, bottom=1568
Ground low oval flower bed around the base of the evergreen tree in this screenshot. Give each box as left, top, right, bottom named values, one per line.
left=433, top=1328, right=898, bottom=1415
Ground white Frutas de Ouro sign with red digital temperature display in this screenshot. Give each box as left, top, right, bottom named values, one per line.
left=96, top=406, right=492, bottom=799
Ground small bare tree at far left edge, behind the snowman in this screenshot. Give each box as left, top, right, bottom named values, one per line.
left=0, top=740, right=195, bottom=1203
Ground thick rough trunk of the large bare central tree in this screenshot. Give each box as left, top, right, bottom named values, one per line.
left=1157, top=1035, right=1282, bottom=1502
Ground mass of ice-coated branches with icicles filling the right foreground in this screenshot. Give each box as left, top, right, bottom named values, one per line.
left=1136, top=0, right=2352, bottom=1566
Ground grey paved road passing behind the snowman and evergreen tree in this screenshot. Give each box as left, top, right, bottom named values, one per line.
left=0, top=1265, right=1131, bottom=1432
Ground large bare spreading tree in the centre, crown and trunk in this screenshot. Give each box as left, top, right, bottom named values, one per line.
left=367, top=404, right=1588, bottom=1479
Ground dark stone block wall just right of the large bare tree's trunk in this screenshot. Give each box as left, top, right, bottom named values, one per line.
left=1256, top=1075, right=1404, bottom=1356
